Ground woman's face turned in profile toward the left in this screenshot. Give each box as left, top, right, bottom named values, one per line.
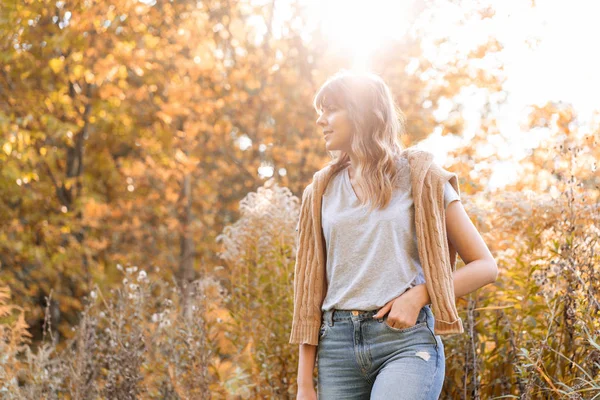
left=317, top=105, right=352, bottom=152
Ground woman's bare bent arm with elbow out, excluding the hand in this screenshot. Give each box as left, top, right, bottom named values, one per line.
left=413, top=201, right=498, bottom=305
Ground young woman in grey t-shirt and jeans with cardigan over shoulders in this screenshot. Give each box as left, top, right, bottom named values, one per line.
left=290, top=70, right=498, bottom=400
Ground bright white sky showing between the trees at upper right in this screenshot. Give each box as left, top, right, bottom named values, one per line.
left=288, top=0, right=600, bottom=189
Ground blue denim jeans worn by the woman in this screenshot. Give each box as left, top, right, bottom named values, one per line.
left=316, top=304, right=446, bottom=400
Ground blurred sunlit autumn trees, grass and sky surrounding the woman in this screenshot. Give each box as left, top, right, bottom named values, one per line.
left=0, top=0, right=600, bottom=399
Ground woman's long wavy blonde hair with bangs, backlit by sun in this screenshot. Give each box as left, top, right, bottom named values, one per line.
left=313, top=69, right=405, bottom=210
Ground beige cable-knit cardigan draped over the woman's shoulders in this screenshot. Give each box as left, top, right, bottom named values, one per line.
left=289, top=147, right=464, bottom=346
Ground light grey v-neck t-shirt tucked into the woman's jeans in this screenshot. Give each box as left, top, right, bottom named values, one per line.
left=321, top=158, right=460, bottom=311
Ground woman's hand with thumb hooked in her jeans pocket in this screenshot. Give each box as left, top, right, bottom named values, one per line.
left=373, top=287, right=425, bottom=329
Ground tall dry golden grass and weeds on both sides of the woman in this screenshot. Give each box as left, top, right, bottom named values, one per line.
left=0, top=139, right=600, bottom=399
